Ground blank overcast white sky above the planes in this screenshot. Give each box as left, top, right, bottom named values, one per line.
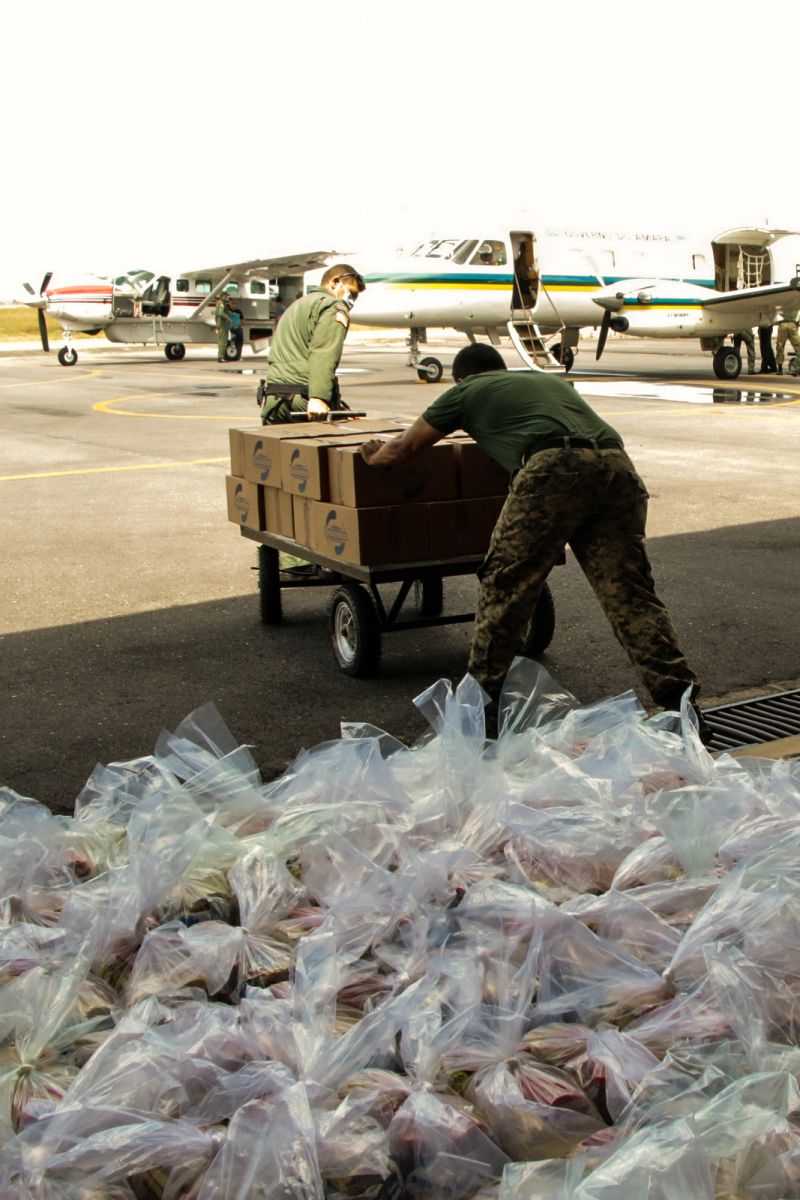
left=0, top=0, right=800, bottom=295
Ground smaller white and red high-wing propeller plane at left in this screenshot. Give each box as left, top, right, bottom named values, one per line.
left=24, top=251, right=331, bottom=366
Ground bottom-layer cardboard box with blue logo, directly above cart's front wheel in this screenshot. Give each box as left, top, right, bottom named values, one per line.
left=294, top=496, right=429, bottom=566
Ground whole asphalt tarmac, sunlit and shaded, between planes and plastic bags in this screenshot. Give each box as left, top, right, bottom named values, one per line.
left=0, top=336, right=800, bottom=811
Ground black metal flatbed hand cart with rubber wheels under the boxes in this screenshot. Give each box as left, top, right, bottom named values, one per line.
left=240, top=527, right=555, bottom=678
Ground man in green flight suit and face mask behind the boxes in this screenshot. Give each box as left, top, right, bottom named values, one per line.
left=259, top=263, right=366, bottom=425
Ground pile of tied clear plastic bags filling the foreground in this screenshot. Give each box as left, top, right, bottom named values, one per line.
left=0, top=660, right=800, bottom=1200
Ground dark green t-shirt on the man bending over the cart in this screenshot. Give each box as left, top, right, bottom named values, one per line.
left=422, top=371, right=622, bottom=472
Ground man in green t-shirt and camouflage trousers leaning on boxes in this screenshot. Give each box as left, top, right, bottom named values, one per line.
left=361, top=343, right=710, bottom=740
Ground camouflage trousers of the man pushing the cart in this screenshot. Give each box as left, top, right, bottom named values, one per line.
left=469, top=448, right=699, bottom=708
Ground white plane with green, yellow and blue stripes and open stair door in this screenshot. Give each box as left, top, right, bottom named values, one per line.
left=338, top=228, right=800, bottom=383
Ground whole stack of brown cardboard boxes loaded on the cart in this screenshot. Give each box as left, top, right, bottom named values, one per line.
left=227, top=419, right=509, bottom=566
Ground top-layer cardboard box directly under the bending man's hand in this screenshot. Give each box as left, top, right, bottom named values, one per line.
left=327, top=442, right=458, bottom=509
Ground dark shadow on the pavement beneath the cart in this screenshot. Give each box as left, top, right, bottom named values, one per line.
left=0, top=518, right=800, bottom=811
